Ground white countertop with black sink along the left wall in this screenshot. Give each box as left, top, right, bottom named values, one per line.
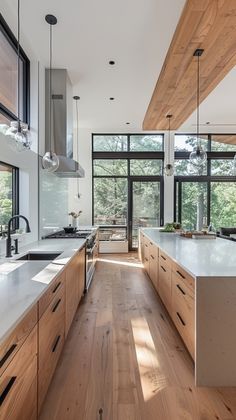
left=0, top=239, right=86, bottom=344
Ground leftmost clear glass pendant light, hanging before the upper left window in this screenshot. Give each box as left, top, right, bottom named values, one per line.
left=5, top=0, right=31, bottom=152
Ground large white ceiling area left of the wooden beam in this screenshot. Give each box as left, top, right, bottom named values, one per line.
left=1, top=0, right=185, bottom=132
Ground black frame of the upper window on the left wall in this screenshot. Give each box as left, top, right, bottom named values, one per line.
left=0, top=13, right=30, bottom=125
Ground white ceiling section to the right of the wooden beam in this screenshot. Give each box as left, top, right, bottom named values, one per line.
left=179, top=68, right=236, bottom=133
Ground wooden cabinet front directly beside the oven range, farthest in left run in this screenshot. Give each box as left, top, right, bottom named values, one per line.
left=65, top=248, right=85, bottom=336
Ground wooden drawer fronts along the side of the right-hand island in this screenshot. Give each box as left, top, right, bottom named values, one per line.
left=139, top=232, right=195, bottom=359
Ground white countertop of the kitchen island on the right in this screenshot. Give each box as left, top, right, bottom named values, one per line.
left=141, top=228, right=236, bottom=277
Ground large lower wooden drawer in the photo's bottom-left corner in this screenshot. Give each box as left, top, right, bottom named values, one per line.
left=0, top=326, right=37, bottom=420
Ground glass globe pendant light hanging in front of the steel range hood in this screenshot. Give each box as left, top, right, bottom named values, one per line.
left=42, top=15, right=59, bottom=172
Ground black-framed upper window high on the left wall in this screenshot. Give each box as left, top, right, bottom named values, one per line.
left=0, top=14, right=30, bottom=124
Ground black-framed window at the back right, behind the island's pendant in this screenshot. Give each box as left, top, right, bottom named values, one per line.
left=174, top=134, right=236, bottom=230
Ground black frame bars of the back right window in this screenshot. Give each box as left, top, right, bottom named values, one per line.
left=174, top=133, right=236, bottom=226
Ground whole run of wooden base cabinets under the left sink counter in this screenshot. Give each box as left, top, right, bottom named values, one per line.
left=0, top=244, right=86, bottom=420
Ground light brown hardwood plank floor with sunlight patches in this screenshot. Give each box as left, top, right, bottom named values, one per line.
left=40, top=254, right=236, bottom=420
